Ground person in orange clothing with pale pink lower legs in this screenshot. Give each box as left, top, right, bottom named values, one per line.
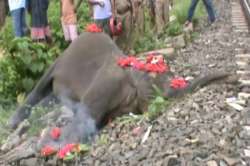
left=61, top=0, right=78, bottom=42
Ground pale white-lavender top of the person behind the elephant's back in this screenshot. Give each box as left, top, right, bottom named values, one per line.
left=93, top=0, right=112, bottom=20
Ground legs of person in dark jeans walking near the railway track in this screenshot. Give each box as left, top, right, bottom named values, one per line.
left=185, top=0, right=216, bottom=26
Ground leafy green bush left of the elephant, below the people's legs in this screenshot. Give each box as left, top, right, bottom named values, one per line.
left=0, top=38, right=58, bottom=99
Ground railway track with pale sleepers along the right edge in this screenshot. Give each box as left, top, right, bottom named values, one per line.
left=230, top=0, right=250, bottom=166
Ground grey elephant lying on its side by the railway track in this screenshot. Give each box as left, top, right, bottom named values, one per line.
left=9, top=32, right=229, bottom=149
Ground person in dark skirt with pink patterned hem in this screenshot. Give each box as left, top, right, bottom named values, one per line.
left=30, top=0, right=52, bottom=43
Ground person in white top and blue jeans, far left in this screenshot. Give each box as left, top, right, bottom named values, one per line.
left=8, top=0, right=27, bottom=37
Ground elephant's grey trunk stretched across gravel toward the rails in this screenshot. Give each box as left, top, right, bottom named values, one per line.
left=164, top=72, right=232, bottom=98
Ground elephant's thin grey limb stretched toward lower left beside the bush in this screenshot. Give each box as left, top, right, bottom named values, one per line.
left=8, top=62, right=56, bottom=129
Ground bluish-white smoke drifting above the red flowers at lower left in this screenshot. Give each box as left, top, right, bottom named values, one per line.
left=37, top=93, right=97, bottom=150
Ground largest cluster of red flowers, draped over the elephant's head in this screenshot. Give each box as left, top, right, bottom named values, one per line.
left=117, top=54, right=169, bottom=73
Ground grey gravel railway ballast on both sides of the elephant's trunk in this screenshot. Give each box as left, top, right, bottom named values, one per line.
left=1, top=0, right=250, bottom=166
